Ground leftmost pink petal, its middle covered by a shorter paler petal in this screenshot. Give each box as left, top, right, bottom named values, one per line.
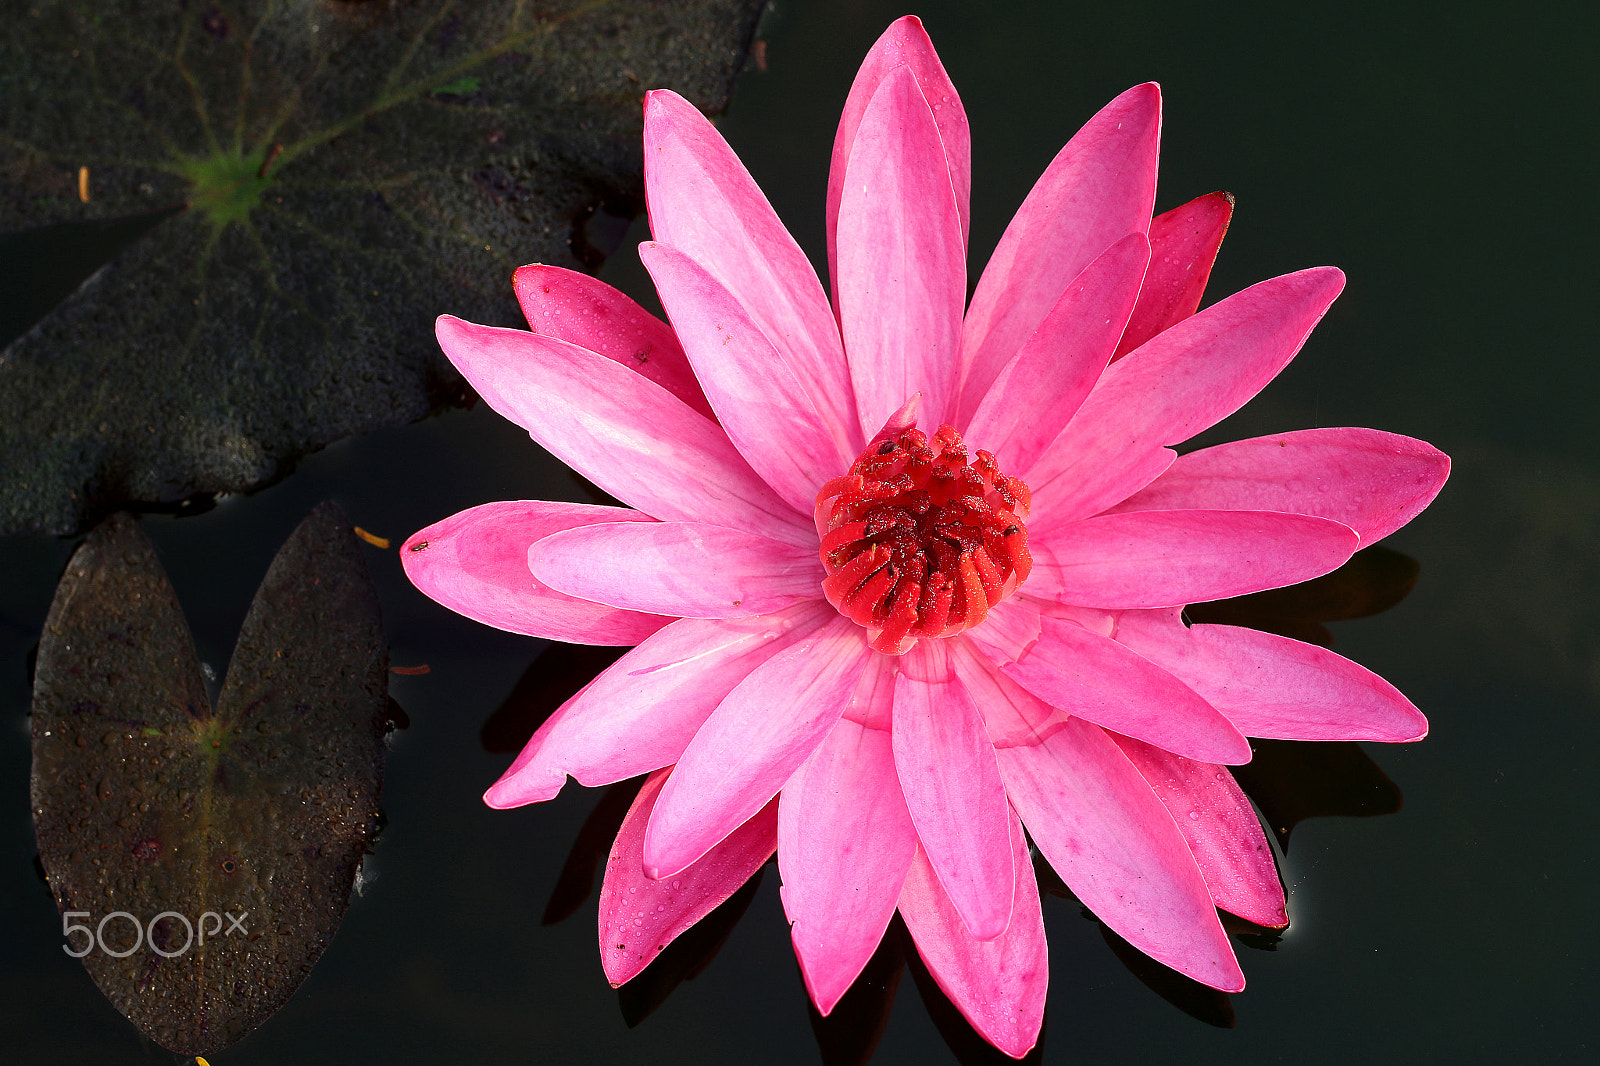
left=400, top=499, right=672, bottom=645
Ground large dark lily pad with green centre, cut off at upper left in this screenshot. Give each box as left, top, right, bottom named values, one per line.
left=0, top=0, right=763, bottom=535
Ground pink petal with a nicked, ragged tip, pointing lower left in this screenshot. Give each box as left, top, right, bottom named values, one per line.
left=483, top=603, right=838, bottom=807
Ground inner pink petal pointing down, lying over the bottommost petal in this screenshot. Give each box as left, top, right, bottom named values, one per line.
left=893, top=640, right=1018, bottom=940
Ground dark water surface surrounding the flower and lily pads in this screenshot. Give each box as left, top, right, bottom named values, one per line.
left=0, top=0, right=1600, bottom=1066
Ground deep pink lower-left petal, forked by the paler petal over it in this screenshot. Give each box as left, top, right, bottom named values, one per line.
left=600, top=770, right=778, bottom=988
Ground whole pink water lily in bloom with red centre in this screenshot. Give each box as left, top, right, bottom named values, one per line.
left=402, top=18, right=1448, bottom=1056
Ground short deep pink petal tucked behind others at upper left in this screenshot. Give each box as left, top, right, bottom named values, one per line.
left=510, top=262, right=715, bottom=418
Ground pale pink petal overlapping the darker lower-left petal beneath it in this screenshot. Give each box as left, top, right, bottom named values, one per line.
left=645, top=615, right=875, bottom=877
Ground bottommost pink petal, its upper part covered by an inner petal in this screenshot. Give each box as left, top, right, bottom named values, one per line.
left=899, top=810, right=1050, bottom=1058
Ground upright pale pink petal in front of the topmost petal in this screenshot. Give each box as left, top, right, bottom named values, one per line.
left=838, top=67, right=966, bottom=439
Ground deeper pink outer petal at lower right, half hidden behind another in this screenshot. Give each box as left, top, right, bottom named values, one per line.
left=1110, top=733, right=1290, bottom=928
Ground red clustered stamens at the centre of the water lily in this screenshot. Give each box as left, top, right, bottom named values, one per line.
left=816, top=426, right=1034, bottom=655
